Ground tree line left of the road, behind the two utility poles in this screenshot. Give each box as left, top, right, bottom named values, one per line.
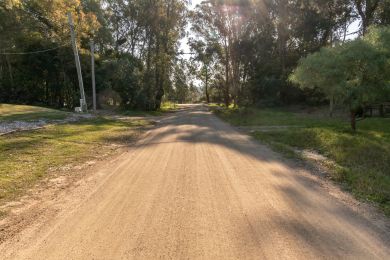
left=0, top=0, right=189, bottom=110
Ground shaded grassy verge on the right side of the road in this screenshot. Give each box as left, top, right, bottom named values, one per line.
left=215, top=105, right=390, bottom=216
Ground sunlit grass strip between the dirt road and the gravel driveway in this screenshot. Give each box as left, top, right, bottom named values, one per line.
left=0, top=117, right=147, bottom=200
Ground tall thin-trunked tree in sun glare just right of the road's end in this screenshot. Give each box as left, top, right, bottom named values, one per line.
left=192, top=0, right=251, bottom=106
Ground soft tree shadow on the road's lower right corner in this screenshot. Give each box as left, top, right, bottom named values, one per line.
left=237, top=181, right=390, bottom=259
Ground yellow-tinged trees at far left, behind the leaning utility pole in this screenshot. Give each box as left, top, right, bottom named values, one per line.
left=0, top=0, right=101, bottom=107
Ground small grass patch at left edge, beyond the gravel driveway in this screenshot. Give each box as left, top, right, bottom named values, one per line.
left=0, top=104, right=70, bottom=121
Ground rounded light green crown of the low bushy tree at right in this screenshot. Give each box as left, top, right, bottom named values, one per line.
left=290, top=25, right=390, bottom=114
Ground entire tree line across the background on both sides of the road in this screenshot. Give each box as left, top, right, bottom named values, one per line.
left=0, top=0, right=390, bottom=115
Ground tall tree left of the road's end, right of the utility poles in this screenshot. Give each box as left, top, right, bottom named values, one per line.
left=105, top=0, right=187, bottom=110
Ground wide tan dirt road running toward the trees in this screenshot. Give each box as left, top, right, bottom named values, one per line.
left=0, top=106, right=390, bottom=259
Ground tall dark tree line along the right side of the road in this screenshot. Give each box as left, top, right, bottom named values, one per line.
left=190, top=0, right=390, bottom=110
